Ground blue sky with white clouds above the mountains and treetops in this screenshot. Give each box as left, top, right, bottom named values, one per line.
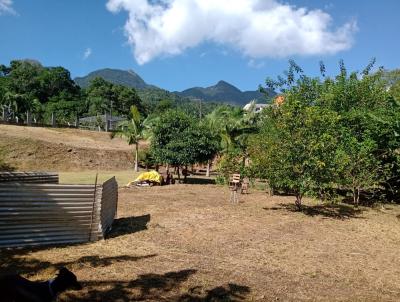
left=0, top=0, right=400, bottom=91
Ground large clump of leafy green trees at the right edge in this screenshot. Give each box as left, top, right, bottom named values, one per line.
left=248, top=62, right=400, bottom=208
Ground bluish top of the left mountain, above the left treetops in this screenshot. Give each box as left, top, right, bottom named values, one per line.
left=74, top=68, right=154, bottom=89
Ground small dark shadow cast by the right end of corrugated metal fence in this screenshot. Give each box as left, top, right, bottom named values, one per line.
left=106, top=214, right=151, bottom=239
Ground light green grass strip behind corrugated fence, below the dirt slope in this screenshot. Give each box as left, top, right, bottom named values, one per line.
left=59, top=170, right=141, bottom=187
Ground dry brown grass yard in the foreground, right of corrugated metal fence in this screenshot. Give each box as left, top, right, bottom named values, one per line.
left=0, top=184, right=400, bottom=302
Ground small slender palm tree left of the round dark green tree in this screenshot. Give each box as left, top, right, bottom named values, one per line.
left=111, top=106, right=145, bottom=172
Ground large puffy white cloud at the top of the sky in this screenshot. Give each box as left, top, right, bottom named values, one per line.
left=107, top=0, right=357, bottom=64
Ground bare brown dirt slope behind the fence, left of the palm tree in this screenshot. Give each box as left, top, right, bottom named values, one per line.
left=0, top=125, right=146, bottom=171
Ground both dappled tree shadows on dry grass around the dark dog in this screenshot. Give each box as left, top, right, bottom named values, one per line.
left=0, top=250, right=250, bottom=302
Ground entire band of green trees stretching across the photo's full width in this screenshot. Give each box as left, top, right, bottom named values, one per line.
left=0, top=60, right=400, bottom=208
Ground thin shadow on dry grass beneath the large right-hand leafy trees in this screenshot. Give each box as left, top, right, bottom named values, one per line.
left=263, top=203, right=363, bottom=219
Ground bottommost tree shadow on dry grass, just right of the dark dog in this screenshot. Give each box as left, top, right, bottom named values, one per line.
left=65, top=269, right=250, bottom=302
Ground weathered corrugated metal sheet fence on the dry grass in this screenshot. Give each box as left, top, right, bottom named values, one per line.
left=0, top=173, right=118, bottom=248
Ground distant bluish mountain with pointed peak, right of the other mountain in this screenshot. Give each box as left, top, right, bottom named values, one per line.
left=175, top=81, right=276, bottom=106
